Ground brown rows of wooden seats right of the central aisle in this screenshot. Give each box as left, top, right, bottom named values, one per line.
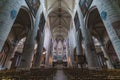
left=64, top=68, right=120, bottom=80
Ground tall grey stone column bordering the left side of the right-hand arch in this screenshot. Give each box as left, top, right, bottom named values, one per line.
left=77, top=8, right=100, bottom=68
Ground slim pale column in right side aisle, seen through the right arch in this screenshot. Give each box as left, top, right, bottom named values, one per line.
left=99, top=41, right=114, bottom=69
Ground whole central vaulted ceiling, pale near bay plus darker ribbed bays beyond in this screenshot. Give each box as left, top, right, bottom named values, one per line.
left=44, top=0, right=76, bottom=39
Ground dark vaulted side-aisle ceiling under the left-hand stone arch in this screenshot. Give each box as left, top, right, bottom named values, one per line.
left=11, top=6, right=34, bottom=40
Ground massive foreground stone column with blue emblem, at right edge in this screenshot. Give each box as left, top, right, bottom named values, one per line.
left=94, top=0, right=120, bottom=60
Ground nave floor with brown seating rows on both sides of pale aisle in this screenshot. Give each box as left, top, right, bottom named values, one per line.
left=0, top=65, right=120, bottom=80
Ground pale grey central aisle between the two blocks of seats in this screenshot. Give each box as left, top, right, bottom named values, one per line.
left=54, top=65, right=67, bottom=80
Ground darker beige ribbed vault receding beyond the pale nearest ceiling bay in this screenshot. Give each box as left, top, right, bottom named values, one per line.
left=49, top=8, right=71, bottom=38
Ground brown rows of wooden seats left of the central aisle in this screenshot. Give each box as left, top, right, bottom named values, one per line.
left=0, top=68, right=56, bottom=80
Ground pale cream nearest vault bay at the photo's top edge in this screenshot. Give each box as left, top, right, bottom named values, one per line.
left=45, top=0, right=75, bottom=14
